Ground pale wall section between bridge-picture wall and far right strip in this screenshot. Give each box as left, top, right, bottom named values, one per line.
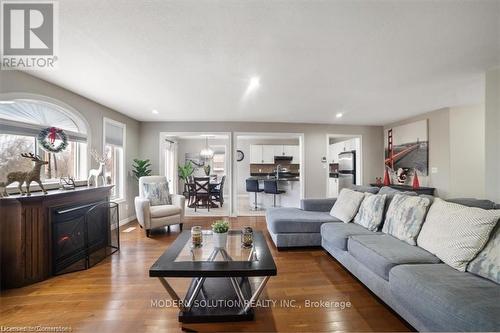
left=450, top=105, right=485, bottom=198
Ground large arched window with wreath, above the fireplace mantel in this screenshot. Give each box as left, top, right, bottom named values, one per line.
left=0, top=98, right=88, bottom=187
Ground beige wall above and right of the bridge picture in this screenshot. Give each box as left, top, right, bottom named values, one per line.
left=384, top=105, right=486, bottom=198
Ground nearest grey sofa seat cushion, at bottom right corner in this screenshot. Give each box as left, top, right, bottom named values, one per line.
left=389, top=264, right=500, bottom=332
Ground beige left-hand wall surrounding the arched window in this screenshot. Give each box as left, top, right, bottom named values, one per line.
left=0, top=71, right=139, bottom=219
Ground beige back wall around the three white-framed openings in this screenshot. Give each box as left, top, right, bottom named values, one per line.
left=139, top=122, right=383, bottom=201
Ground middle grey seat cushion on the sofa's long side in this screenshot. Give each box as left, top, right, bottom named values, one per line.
left=347, top=235, right=440, bottom=280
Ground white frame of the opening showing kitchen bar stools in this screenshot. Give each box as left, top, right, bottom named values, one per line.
left=231, top=132, right=306, bottom=216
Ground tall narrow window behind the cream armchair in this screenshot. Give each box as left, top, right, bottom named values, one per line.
left=103, top=118, right=125, bottom=200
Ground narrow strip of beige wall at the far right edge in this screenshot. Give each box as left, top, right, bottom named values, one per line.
left=485, top=68, right=500, bottom=203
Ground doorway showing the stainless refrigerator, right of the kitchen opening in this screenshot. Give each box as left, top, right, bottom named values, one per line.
left=326, top=134, right=363, bottom=198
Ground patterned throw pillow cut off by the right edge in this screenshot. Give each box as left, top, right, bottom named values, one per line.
left=467, top=222, right=500, bottom=284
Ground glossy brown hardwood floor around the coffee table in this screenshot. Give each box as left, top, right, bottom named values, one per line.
left=0, top=217, right=411, bottom=333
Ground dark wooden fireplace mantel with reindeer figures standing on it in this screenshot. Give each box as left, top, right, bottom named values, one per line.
left=0, top=185, right=113, bottom=289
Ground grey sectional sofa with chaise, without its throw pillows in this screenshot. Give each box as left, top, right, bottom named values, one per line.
left=266, top=187, right=500, bottom=331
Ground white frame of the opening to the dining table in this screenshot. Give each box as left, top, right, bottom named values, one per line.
left=158, top=131, right=234, bottom=216
